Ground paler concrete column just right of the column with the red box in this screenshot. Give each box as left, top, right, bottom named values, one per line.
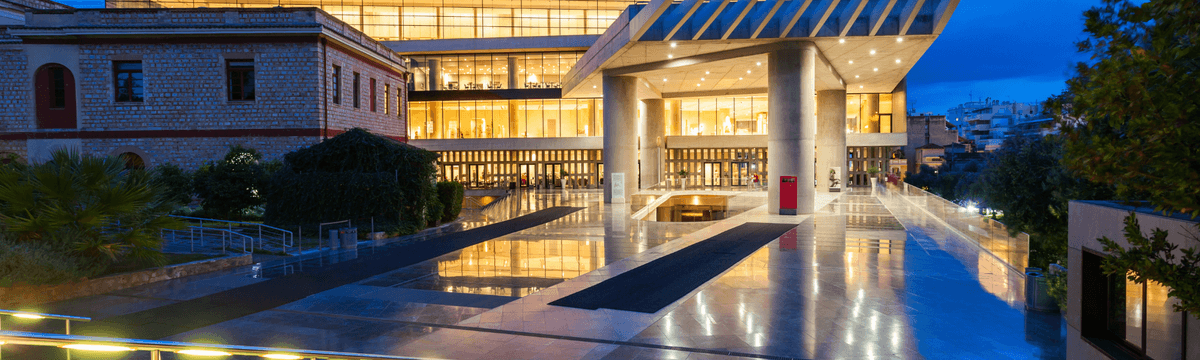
left=816, top=90, right=848, bottom=191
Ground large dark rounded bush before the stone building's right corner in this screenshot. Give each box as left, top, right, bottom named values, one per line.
left=264, top=128, right=443, bottom=234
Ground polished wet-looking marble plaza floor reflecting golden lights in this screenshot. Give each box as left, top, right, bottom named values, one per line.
left=35, top=187, right=1064, bottom=360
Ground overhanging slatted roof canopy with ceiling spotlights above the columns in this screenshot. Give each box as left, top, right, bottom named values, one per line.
left=563, top=0, right=959, bottom=97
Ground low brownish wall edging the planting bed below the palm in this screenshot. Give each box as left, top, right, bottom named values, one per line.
left=0, top=254, right=251, bottom=308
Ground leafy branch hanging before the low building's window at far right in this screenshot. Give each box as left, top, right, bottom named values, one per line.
left=1098, top=212, right=1200, bottom=313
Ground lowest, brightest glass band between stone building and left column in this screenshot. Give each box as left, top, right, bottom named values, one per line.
left=408, top=98, right=604, bottom=139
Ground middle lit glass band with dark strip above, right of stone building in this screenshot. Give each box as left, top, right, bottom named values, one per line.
left=409, top=52, right=583, bottom=91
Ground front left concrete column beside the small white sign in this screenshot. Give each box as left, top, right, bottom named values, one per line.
left=604, top=76, right=637, bottom=203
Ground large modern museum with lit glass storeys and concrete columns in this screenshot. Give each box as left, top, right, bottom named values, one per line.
left=6, top=0, right=958, bottom=212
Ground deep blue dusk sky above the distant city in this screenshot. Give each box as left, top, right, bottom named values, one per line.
left=62, top=0, right=1100, bottom=114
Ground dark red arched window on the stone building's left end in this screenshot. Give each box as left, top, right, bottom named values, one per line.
left=34, top=64, right=76, bottom=128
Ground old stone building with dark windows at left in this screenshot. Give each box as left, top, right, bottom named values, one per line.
left=0, top=7, right=408, bottom=168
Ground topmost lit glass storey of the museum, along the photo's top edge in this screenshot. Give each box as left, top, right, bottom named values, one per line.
left=106, top=0, right=635, bottom=41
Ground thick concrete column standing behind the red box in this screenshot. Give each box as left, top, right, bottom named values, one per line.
left=767, top=42, right=817, bottom=214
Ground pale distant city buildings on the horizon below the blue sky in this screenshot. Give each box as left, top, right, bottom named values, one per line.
left=946, top=100, right=1051, bottom=151
